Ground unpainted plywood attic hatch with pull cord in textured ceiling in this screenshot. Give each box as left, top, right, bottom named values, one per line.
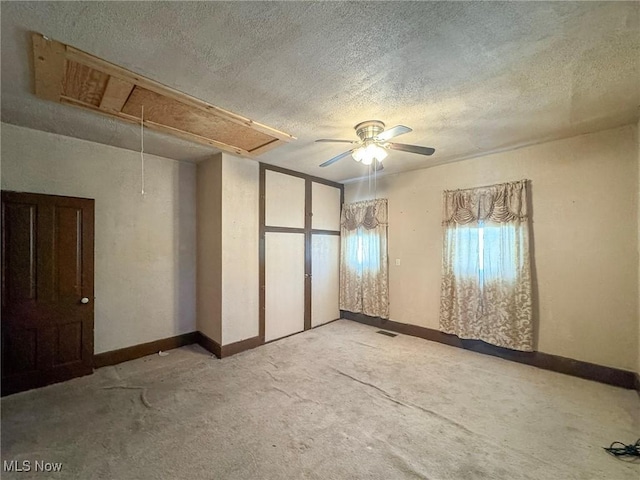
left=32, top=33, right=295, bottom=158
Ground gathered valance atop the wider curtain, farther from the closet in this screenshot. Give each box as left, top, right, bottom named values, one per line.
left=442, top=180, right=528, bottom=225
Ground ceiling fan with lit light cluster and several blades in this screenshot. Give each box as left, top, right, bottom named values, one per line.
left=316, top=120, right=435, bottom=171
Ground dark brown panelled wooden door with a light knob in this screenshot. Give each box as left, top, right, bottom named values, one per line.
left=2, top=191, right=94, bottom=395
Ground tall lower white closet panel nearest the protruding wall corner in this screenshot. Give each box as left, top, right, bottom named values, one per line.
left=264, top=232, right=304, bottom=342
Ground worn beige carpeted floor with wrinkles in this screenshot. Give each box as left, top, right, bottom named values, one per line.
left=2, top=320, right=640, bottom=480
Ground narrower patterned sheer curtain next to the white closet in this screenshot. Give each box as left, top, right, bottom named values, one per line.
left=340, top=199, right=389, bottom=318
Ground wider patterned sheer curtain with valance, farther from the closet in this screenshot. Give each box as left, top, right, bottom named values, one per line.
left=440, top=180, right=533, bottom=351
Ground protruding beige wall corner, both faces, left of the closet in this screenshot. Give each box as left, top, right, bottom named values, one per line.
left=197, top=153, right=259, bottom=345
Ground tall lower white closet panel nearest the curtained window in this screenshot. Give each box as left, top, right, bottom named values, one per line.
left=311, top=234, right=340, bottom=327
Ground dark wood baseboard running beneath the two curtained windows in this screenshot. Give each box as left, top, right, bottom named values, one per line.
left=340, top=310, right=640, bottom=392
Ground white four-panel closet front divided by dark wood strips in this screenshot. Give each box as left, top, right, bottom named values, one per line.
left=260, top=166, right=341, bottom=342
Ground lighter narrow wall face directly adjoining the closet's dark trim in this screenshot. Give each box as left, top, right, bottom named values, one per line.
left=222, top=153, right=259, bottom=345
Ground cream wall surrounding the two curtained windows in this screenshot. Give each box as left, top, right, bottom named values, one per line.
left=345, top=125, right=639, bottom=370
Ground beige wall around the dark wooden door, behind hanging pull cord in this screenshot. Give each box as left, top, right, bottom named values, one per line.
left=2, top=123, right=196, bottom=353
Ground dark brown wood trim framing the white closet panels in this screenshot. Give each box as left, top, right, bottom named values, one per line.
left=258, top=162, right=344, bottom=343
